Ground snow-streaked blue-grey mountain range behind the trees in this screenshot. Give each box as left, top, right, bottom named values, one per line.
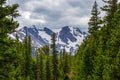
left=10, top=26, right=87, bottom=53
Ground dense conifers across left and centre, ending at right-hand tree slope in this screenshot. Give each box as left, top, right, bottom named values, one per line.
left=0, top=0, right=71, bottom=80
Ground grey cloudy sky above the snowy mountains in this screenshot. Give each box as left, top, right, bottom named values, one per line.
left=8, top=0, right=107, bottom=30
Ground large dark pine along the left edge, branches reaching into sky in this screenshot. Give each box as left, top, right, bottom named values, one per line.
left=0, top=0, right=19, bottom=80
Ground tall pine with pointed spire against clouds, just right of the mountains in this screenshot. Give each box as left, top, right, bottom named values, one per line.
left=75, top=1, right=101, bottom=80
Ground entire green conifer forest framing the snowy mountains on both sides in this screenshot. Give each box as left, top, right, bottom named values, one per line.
left=0, top=0, right=120, bottom=80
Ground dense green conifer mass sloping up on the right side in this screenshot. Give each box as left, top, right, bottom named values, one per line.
left=73, top=0, right=120, bottom=80
